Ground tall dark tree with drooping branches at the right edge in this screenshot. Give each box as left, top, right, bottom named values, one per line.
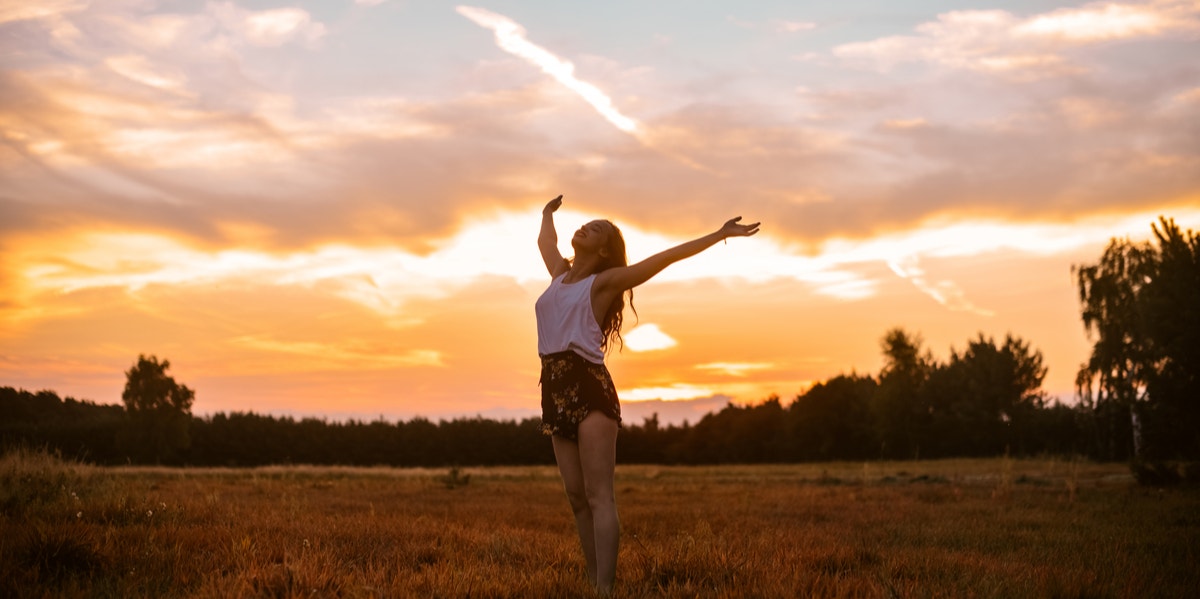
left=1074, top=217, right=1200, bottom=459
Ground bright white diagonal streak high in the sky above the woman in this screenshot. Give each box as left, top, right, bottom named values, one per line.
left=455, top=6, right=641, bottom=140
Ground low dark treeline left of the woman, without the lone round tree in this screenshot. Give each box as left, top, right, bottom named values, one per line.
left=0, top=387, right=554, bottom=467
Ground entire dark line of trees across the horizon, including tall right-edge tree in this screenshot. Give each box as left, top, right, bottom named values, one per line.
left=0, top=218, right=1200, bottom=477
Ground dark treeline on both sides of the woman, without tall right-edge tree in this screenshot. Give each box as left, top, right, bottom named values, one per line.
left=0, top=329, right=1100, bottom=467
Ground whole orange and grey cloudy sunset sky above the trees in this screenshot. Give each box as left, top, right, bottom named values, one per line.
left=0, top=0, right=1200, bottom=423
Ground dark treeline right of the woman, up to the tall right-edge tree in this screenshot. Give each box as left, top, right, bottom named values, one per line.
left=617, top=329, right=1102, bottom=463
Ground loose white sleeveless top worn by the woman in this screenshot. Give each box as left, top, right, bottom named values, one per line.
left=534, top=272, right=604, bottom=364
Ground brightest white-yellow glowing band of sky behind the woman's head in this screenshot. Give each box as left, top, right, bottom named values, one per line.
left=7, top=206, right=1200, bottom=328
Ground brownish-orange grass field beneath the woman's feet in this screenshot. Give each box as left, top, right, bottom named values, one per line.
left=0, top=453, right=1200, bottom=598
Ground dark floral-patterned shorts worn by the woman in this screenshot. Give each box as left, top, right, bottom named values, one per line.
left=540, top=352, right=620, bottom=441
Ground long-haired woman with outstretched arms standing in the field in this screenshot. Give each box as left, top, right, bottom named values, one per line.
left=535, top=196, right=758, bottom=594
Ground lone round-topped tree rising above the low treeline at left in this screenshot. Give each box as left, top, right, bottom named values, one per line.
left=118, top=355, right=196, bottom=463
